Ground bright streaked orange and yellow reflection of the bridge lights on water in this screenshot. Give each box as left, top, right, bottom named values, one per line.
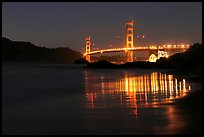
left=85, top=71, right=191, bottom=117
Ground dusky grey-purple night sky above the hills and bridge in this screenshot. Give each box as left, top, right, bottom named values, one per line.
left=2, top=2, right=202, bottom=51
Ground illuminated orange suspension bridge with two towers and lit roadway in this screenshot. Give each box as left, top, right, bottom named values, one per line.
left=83, top=20, right=190, bottom=62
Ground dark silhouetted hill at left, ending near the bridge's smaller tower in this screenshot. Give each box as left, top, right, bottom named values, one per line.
left=2, top=38, right=82, bottom=64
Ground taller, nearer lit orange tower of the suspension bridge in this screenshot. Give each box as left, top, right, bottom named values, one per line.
left=125, top=20, right=134, bottom=62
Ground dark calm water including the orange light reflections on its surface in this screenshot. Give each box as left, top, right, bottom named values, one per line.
left=2, top=64, right=202, bottom=135
